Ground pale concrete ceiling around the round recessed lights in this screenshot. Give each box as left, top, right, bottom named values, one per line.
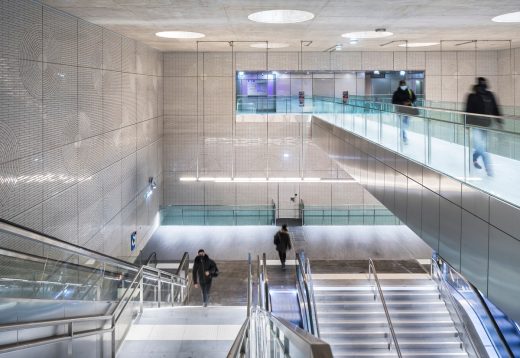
left=43, top=0, right=520, bottom=51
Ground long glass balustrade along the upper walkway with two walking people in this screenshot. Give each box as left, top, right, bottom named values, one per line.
left=237, top=96, right=520, bottom=210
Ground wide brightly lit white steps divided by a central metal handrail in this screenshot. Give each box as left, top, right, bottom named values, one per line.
left=313, top=274, right=468, bottom=358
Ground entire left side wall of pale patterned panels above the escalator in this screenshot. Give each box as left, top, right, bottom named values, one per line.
left=0, top=0, right=162, bottom=262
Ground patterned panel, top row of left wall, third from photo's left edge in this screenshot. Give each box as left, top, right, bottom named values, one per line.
left=78, top=20, right=103, bottom=68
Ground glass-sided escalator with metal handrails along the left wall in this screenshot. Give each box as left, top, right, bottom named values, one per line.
left=0, top=220, right=189, bottom=358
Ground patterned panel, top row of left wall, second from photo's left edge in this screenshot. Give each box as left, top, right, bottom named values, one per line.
left=43, top=7, right=78, bottom=66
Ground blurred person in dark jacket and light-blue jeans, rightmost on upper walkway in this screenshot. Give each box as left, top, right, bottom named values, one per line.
left=466, top=77, right=503, bottom=176
